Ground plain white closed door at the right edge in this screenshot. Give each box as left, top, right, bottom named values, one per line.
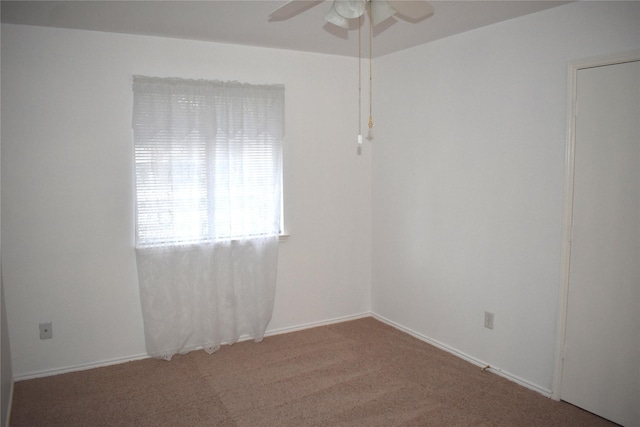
left=560, top=61, right=640, bottom=427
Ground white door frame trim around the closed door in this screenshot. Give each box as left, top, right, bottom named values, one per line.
left=551, top=49, right=640, bottom=400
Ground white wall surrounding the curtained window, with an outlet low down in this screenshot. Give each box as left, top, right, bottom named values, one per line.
left=2, top=25, right=371, bottom=379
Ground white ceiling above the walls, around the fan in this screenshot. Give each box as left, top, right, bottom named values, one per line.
left=1, top=0, right=568, bottom=56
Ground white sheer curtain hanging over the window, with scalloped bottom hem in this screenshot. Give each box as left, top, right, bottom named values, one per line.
left=133, top=76, right=284, bottom=360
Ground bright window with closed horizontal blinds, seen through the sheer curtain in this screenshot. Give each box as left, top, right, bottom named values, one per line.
left=133, top=76, right=284, bottom=247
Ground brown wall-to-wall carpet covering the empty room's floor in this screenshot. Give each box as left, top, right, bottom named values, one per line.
left=10, top=318, right=614, bottom=427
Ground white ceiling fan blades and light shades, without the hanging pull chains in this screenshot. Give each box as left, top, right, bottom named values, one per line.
left=269, top=0, right=433, bottom=28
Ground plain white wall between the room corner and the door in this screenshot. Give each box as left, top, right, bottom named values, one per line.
left=372, top=2, right=640, bottom=393
